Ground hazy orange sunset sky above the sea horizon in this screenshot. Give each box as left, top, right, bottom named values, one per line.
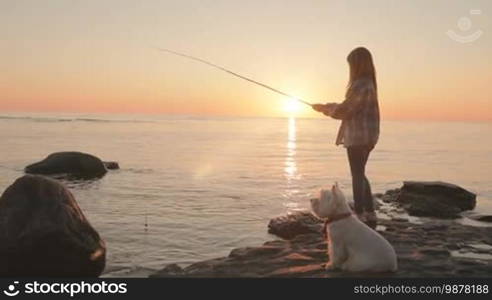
left=0, top=0, right=492, bottom=121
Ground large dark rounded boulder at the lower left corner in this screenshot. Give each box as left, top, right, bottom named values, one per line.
left=0, top=175, right=106, bottom=277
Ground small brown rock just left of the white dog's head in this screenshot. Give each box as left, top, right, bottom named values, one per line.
left=268, top=212, right=323, bottom=239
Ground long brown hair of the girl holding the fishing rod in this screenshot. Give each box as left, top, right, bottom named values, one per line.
left=347, top=47, right=378, bottom=91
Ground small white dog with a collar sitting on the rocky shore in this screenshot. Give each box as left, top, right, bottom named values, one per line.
left=311, top=184, right=397, bottom=272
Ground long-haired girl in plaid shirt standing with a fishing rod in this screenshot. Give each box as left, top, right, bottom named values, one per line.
left=313, top=47, right=379, bottom=228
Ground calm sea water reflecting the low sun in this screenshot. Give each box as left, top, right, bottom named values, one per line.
left=0, top=114, right=492, bottom=276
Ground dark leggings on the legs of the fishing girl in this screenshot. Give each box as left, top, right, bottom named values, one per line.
left=347, top=145, right=374, bottom=214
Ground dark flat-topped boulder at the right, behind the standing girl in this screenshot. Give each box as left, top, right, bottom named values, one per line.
left=396, top=181, right=476, bottom=218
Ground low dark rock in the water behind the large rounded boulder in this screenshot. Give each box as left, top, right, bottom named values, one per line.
left=25, top=152, right=107, bottom=179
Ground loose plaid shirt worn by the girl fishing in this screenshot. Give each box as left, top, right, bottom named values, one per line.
left=330, top=79, right=379, bottom=147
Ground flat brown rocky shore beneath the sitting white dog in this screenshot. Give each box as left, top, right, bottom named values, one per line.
left=151, top=213, right=492, bottom=278
